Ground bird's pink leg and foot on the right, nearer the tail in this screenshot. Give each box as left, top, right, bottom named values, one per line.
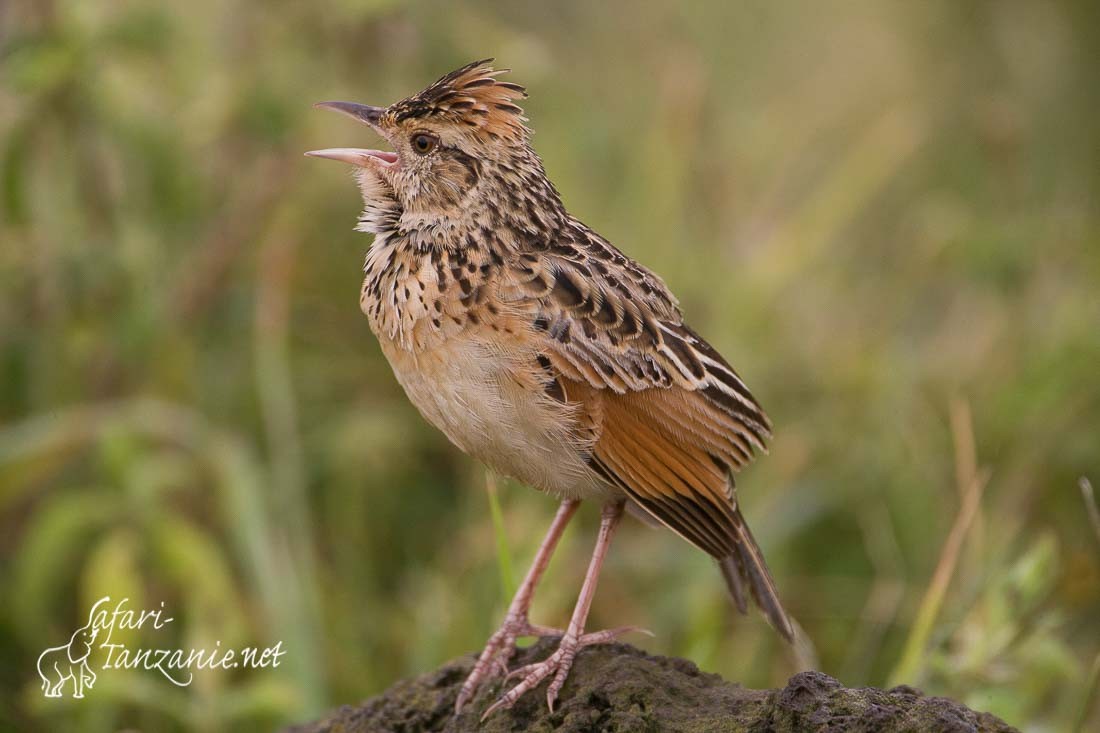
left=482, top=501, right=642, bottom=720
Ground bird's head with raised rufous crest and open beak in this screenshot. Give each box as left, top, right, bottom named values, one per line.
left=307, top=59, right=545, bottom=231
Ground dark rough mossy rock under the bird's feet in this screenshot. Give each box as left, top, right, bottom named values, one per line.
left=288, top=639, right=1015, bottom=733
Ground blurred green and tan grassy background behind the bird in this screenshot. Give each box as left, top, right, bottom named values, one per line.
left=0, top=0, right=1100, bottom=732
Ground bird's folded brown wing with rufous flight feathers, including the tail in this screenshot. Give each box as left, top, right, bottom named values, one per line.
left=510, top=217, right=791, bottom=638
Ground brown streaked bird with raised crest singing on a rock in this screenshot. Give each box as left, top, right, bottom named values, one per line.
left=306, top=58, right=794, bottom=716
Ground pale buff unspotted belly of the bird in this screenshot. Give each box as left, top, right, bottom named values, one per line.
left=382, top=337, right=615, bottom=499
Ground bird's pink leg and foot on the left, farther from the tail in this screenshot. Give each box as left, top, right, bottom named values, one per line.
left=454, top=499, right=580, bottom=712
